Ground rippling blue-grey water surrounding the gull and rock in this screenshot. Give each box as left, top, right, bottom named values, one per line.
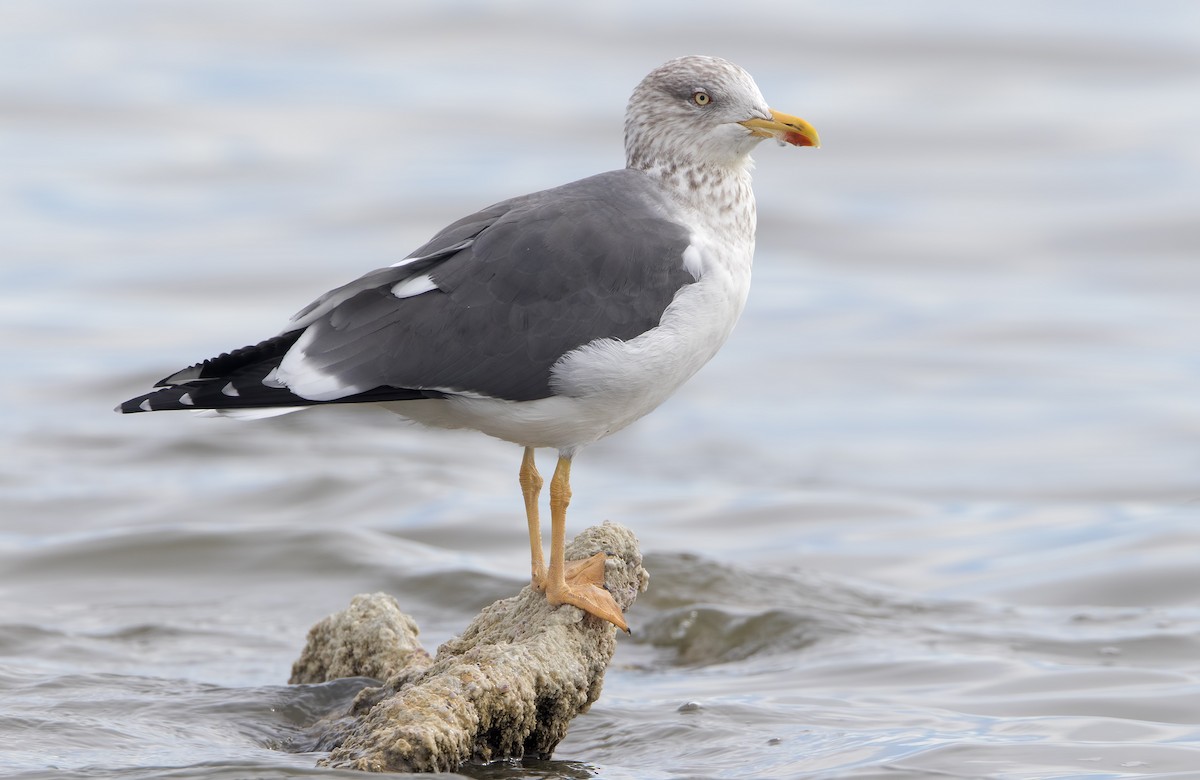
left=0, top=0, right=1200, bottom=780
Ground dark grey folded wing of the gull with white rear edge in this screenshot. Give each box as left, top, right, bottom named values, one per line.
left=278, top=170, right=696, bottom=401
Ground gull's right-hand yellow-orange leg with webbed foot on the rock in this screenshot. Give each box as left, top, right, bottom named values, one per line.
left=546, top=456, right=629, bottom=632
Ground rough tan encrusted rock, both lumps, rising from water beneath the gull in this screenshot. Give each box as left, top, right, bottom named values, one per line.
left=292, top=523, right=649, bottom=772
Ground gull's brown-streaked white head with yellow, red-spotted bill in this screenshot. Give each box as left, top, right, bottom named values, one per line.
left=625, top=55, right=821, bottom=169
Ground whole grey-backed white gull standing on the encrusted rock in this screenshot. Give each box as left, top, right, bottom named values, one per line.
left=118, top=56, right=820, bottom=631
